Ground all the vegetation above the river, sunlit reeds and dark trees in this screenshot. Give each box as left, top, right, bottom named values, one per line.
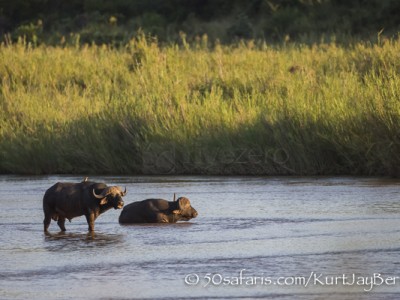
left=0, top=0, right=400, bottom=176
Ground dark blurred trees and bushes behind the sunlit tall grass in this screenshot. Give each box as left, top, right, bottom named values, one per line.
left=0, top=0, right=400, bottom=44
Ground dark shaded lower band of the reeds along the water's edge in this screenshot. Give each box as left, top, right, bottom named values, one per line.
left=0, top=115, right=400, bottom=176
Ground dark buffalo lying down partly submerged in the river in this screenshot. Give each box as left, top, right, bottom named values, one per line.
left=119, top=197, right=197, bottom=224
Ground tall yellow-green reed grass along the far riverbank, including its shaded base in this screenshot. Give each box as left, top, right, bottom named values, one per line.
left=0, top=37, right=400, bottom=175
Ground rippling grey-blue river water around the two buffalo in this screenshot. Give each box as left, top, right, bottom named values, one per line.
left=0, top=176, right=400, bottom=299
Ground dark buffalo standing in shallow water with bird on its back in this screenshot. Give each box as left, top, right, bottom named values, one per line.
left=43, top=178, right=126, bottom=231
